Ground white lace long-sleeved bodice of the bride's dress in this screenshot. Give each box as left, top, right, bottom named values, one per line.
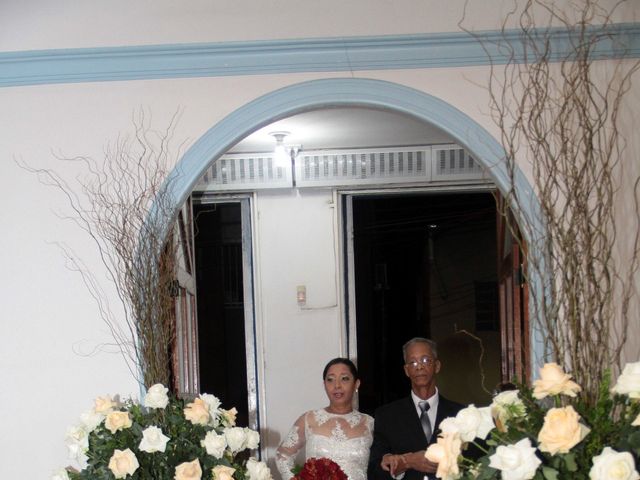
left=276, top=409, right=373, bottom=480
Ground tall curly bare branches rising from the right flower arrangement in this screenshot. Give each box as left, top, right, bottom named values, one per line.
left=462, top=0, right=640, bottom=403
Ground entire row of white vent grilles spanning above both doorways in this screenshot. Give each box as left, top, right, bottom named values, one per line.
left=196, top=145, right=489, bottom=191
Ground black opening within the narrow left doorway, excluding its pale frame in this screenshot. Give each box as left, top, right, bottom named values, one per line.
left=194, top=203, right=249, bottom=425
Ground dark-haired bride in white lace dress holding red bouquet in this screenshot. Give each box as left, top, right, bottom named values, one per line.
left=276, top=358, right=373, bottom=480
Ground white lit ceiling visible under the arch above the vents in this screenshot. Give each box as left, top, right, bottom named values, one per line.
left=229, top=107, right=454, bottom=153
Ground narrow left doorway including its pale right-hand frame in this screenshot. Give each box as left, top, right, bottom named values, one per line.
left=193, top=195, right=257, bottom=428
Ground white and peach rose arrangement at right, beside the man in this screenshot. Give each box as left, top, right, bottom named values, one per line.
left=425, top=362, right=640, bottom=480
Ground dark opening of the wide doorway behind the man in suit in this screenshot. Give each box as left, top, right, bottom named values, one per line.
left=353, top=192, right=500, bottom=413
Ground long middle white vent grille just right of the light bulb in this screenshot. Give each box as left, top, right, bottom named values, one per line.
left=295, top=147, right=431, bottom=187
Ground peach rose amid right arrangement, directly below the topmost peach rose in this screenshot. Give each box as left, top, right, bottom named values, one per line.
left=538, top=405, right=590, bottom=455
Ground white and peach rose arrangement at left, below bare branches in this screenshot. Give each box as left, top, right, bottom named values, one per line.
left=53, top=384, right=272, bottom=480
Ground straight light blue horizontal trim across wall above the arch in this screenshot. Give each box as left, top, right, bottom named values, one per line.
left=0, top=23, right=640, bottom=87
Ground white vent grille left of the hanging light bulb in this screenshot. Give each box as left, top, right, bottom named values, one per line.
left=196, top=154, right=291, bottom=191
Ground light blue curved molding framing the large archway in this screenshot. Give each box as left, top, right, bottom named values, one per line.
left=168, top=78, right=543, bottom=376
